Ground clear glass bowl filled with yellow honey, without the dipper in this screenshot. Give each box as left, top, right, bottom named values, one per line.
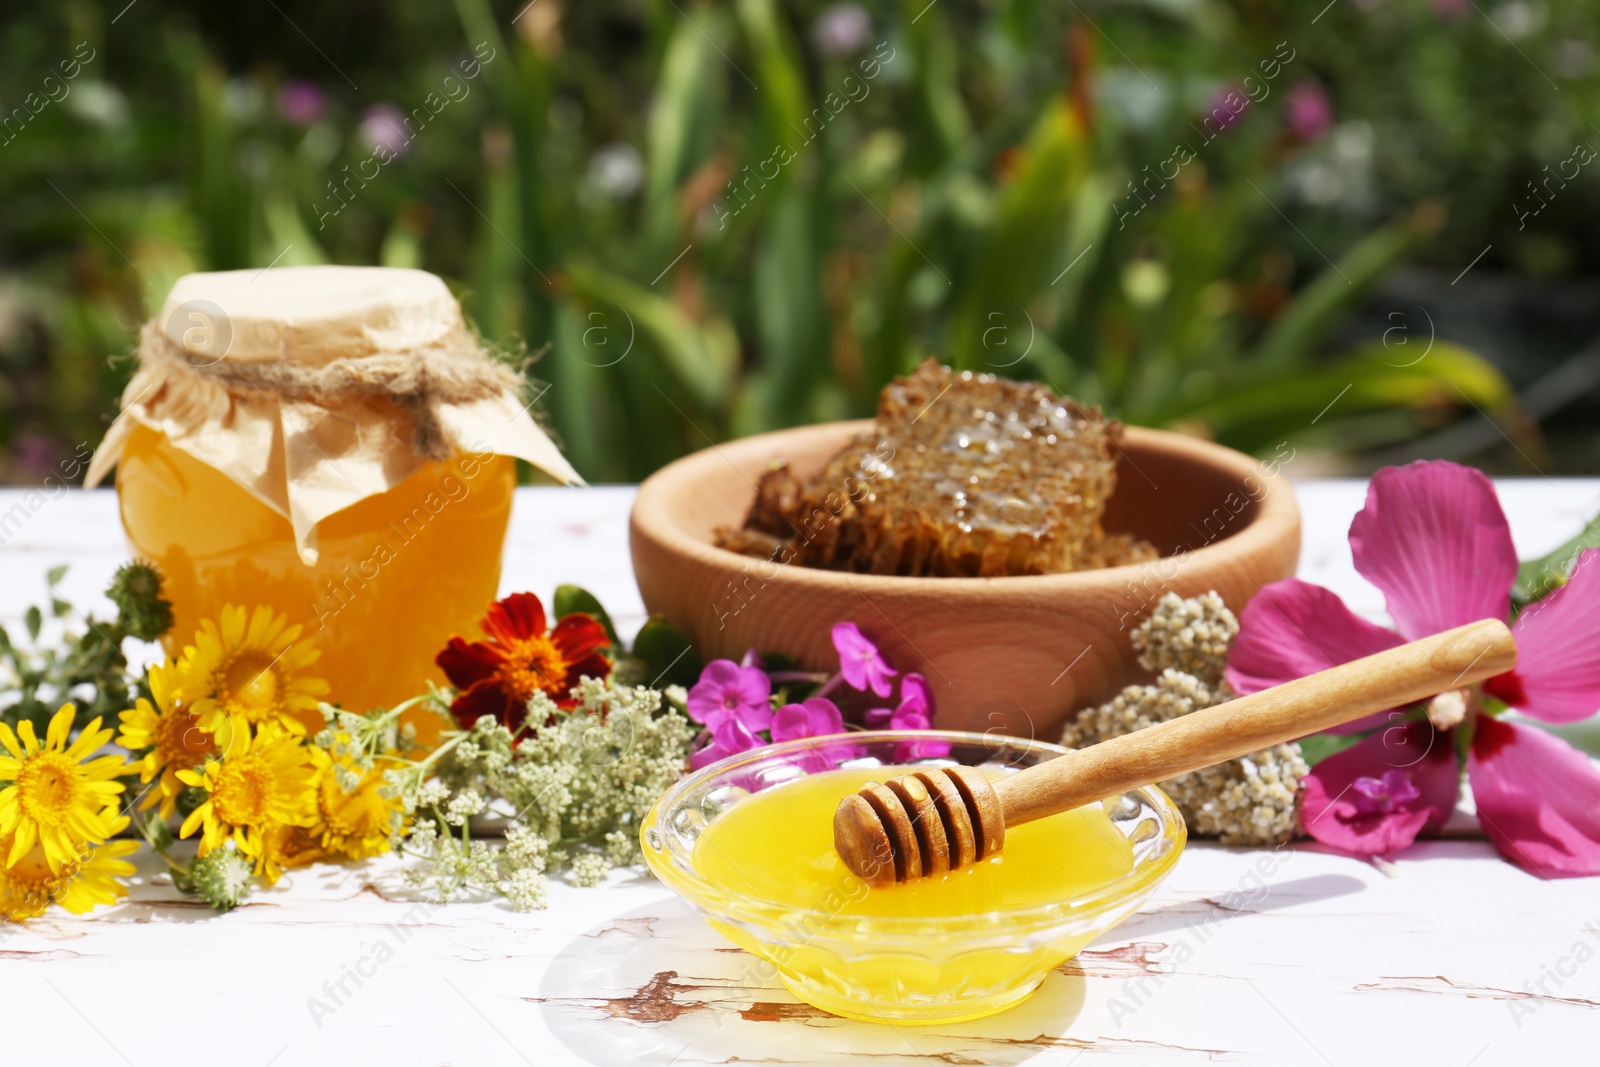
left=640, top=729, right=1186, bottom=1025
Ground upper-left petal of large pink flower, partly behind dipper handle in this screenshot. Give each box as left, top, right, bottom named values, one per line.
left=1227, top=577, right=1405, bottom=734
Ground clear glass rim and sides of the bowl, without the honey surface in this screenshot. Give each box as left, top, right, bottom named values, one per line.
left=640, top=729, right=1186, bottom=1024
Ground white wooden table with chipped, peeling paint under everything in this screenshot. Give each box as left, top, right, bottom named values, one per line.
left=0, top=480, right=1600, bottom=1067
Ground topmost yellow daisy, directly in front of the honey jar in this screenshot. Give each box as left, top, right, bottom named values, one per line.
left=178, top=605, right=328, bottom=734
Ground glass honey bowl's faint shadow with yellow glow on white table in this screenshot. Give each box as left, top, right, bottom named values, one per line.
left=526, top=901, right=1093, bottom=1067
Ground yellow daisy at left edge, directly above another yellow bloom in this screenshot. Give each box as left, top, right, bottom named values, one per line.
left=0, top=704, right=131, bottom=873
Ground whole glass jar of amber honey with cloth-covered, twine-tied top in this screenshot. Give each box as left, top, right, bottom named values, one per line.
left=90, top=267, right=579, bottom=728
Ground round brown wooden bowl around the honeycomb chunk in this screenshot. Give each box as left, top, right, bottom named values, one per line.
left=629, top=421, right=1299, bottom=741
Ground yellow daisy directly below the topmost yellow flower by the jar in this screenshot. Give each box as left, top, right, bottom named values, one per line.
left=178, top=717, right=317, bottom=883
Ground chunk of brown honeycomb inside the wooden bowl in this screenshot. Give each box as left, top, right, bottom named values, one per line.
left=717, top=360, right=1155, bottom=577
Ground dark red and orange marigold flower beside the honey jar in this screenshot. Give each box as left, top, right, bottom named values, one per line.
left=434, top=593, right=611, bottom=729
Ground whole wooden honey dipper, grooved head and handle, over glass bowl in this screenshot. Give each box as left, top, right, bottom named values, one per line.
left=834, top=619, right=1517, bottom=886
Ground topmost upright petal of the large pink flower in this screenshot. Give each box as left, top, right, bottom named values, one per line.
left=1350, top=461, right=1517, bottom=640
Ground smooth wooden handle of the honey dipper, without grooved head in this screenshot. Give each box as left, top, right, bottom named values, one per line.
left=995, top=619, right=1517, bottom=825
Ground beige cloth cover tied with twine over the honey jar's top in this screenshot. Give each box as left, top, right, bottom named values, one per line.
left=86, top=267, right=582, bottom=563
